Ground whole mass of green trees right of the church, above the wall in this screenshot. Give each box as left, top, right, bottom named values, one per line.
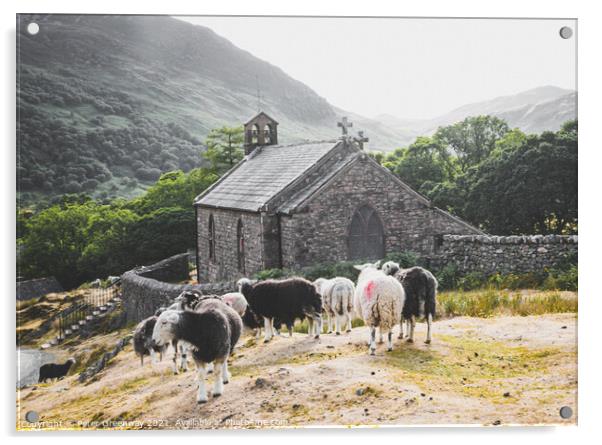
left=381, top=116, right=577, bottom=235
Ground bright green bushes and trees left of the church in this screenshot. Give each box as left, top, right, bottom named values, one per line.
left=18, top=168, right=217, bottom=288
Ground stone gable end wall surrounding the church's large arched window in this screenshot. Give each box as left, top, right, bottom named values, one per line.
left=281, top=157, right=480, bottom=268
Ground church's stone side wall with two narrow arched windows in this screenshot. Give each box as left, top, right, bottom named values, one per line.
left=197, top=207, right=263, bottom=283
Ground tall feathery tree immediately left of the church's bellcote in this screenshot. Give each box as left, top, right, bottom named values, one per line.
left=203, top=127, right=244, bottom=175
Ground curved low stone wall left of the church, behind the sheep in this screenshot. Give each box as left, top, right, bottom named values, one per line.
left=121, top=254, right=236, bottom=323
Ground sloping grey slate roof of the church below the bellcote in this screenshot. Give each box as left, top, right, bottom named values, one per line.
left=194, top=141, right=338, bottom=212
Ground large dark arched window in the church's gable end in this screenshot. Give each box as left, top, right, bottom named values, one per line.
left=348, top=205, right=385, bottom=260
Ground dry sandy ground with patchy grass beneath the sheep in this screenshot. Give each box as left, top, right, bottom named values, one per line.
left=17, top=314, right=577, bottom=429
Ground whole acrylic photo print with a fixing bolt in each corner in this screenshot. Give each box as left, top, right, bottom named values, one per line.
left=16, top=14, right=578, bottom=430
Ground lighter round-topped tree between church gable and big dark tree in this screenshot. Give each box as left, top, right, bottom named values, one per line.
left=434, top=116, right=509, bottom=173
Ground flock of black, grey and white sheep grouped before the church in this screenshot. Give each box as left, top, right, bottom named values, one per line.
left=134, top=261, right=437, bottom=403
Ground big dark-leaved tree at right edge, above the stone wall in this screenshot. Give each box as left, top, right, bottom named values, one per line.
left=466, top=122, right=577, bottom=235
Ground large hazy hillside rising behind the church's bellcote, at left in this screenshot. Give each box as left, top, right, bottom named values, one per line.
left=17, top=15, right=412, bottom=198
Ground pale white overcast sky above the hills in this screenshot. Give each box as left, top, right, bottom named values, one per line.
left=178, top=16, right=577, bottom=119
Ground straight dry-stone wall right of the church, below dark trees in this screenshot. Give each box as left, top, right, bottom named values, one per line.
left=431, top=235, right=578, bottom=275
